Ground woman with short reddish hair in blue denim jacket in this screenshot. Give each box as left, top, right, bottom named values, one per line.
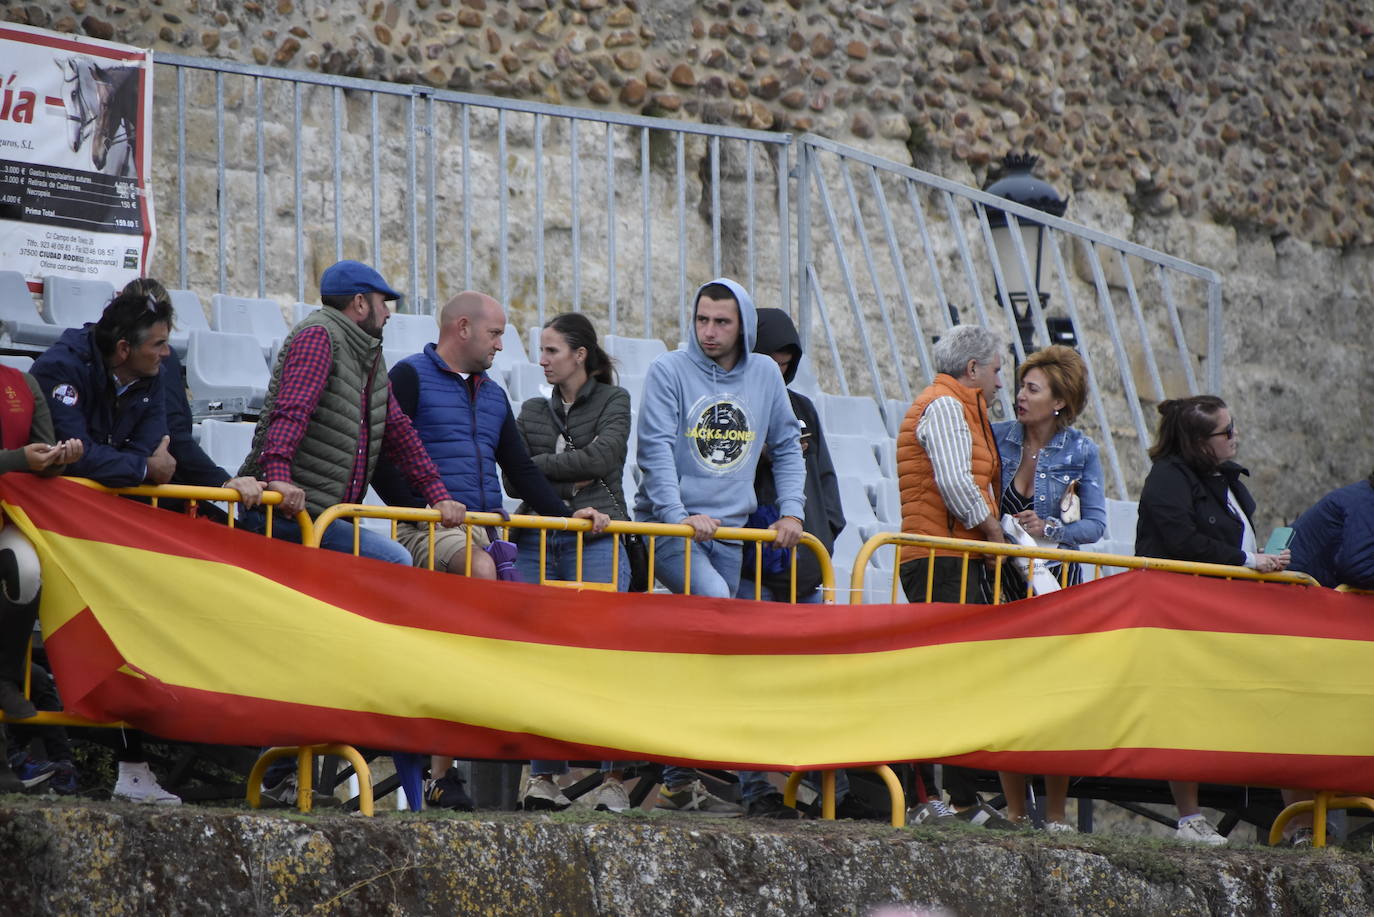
left=992, top=345, right=1107, bottom=832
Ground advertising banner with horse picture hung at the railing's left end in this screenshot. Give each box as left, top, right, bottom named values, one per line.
left=0, top=23, right=154, bottom=287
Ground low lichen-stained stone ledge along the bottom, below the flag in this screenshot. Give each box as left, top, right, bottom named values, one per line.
left=8, top=796, right=1374, bottom=917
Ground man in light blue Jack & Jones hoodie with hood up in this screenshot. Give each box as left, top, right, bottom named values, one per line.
left=635, top=278, right=807, bottom=815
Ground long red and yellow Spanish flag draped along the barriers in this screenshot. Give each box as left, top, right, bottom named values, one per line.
left=0, top=474, right=1374, bottom=789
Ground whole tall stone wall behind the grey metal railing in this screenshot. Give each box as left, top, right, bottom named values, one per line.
left=0, top=0, right=1374, bottom=529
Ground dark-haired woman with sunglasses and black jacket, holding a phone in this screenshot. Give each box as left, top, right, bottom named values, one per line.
left=1135, top=395, right=1289, bottom=846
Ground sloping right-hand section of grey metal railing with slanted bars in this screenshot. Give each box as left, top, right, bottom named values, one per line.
left=794, top=133, right=1221, bottom=499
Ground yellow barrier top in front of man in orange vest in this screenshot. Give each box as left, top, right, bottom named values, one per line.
left=849, top=532, right=1318, bottom=605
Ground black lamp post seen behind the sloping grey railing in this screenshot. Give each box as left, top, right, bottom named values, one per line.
left=984, top=153, right=1077, bottom=352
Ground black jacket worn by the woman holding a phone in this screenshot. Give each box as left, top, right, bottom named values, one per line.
left=1135, top=455, right=1254, bottom=566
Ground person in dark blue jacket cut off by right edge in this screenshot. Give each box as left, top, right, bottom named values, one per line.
left=1289, top=473, right=1374, bottom=588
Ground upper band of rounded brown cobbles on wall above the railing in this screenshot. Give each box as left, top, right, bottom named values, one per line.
left=13, top=0, right=1374, bottom=247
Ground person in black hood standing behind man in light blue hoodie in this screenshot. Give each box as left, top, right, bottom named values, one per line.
left=736, top=309, right=845, bottom=604
